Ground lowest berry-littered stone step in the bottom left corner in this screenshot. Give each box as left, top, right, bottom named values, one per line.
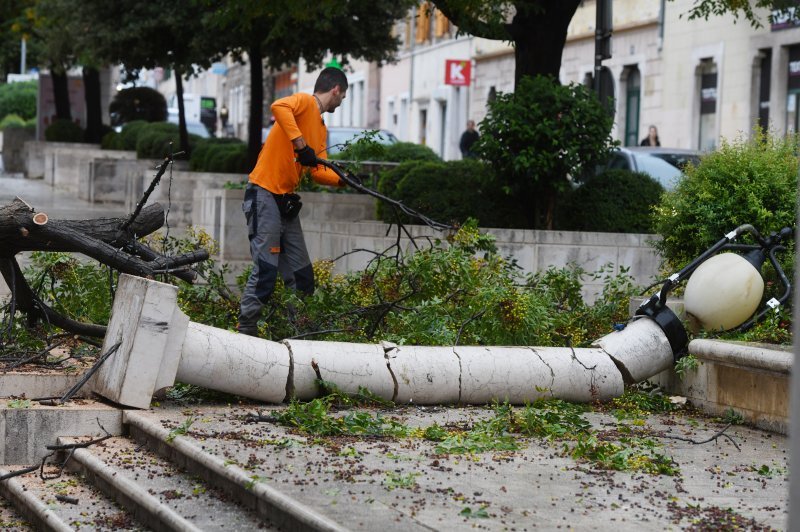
left=0, top=466, right=149, bottom=532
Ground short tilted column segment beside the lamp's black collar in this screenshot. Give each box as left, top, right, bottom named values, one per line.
left=593, top=318, right=674, bottom=384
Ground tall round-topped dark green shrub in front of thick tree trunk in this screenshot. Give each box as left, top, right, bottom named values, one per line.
left=473, top=76, right=615, bottom=229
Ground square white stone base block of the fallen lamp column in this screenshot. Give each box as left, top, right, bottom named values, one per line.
left=91, top=275, right=189, bottom=408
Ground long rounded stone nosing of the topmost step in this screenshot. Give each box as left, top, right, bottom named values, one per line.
left=123, top=411, right=347, bottom=532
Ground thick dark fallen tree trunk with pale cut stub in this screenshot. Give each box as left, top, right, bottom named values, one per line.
left=0, top=198, right=208, bottom=337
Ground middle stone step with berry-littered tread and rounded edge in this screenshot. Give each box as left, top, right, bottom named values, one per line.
left=59, top=437, right=274, bottom=531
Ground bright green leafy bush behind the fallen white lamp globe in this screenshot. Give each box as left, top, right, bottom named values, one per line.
left=654, top=130, right=798, bottom=270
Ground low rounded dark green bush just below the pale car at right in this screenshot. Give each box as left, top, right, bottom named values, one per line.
left=556, top=170, right=664, bottom=233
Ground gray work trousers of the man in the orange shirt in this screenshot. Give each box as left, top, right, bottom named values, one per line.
left=239, top=183, right=314, bottom=329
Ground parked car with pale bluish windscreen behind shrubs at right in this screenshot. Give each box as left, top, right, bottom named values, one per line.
left=600, top=146, right=700, bottom=190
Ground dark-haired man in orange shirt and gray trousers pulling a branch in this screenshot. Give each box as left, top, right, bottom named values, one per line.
left=238, top=67, right=347, bottom=336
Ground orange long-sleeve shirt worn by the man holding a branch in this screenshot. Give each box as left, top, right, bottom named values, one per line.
left=250, top=93, right=339, bottom=194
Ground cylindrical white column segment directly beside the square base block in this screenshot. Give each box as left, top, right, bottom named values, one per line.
left=177, top=322, right=290, bottom=403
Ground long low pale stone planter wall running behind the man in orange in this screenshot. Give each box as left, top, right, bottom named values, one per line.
left=20, top=145, right=659, bottom=300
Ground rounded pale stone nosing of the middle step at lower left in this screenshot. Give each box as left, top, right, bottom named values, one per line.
left=58, top=438, right=200, bottom=532
